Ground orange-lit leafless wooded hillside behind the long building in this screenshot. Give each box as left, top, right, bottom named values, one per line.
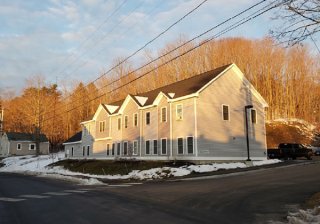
left=2, top=37, right=320, bottom=149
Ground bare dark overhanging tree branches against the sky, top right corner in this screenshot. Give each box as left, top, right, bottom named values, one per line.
left=271, top=0, right=320, bottom=46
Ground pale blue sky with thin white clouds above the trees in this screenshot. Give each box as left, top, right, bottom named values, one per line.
left=0, top=0, right=320, bottom=93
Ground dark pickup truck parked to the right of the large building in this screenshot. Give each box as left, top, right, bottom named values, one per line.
left=268, top=143, right=313, bottom=159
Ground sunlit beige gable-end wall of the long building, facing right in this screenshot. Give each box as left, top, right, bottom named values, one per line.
left=197, top=70, right=266, bottom=160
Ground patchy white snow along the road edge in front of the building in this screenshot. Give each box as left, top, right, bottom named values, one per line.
left=0, top=153, right=281, bottom=185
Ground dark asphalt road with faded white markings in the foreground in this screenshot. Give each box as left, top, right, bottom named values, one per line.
left=0, top=162, right=320, bottom=224
